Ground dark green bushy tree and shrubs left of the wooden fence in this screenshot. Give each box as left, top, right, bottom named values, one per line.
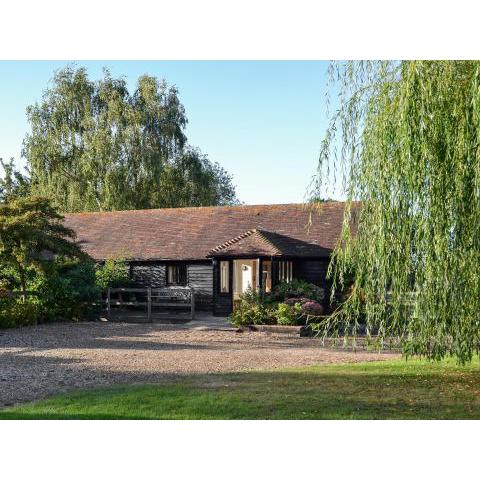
left=0, top=196, right=100, bottom=327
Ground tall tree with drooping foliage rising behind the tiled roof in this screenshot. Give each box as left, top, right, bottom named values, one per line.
left=23, top=67, right=236, bottom=211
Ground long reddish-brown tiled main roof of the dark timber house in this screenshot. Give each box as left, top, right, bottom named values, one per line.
left=65, top=202, right=350, bottom=260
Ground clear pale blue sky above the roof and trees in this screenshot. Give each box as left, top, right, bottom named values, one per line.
left=0, top=61, right=341, bottom=205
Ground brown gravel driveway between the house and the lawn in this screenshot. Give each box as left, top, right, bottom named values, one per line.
left=0, top=322, right=394, bottom=406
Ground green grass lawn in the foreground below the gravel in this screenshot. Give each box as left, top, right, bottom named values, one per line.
left=0, top=360, right=480, bottom=419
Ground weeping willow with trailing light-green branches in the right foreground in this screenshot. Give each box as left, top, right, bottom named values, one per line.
left=316, top=61, right=480, bottom=362
